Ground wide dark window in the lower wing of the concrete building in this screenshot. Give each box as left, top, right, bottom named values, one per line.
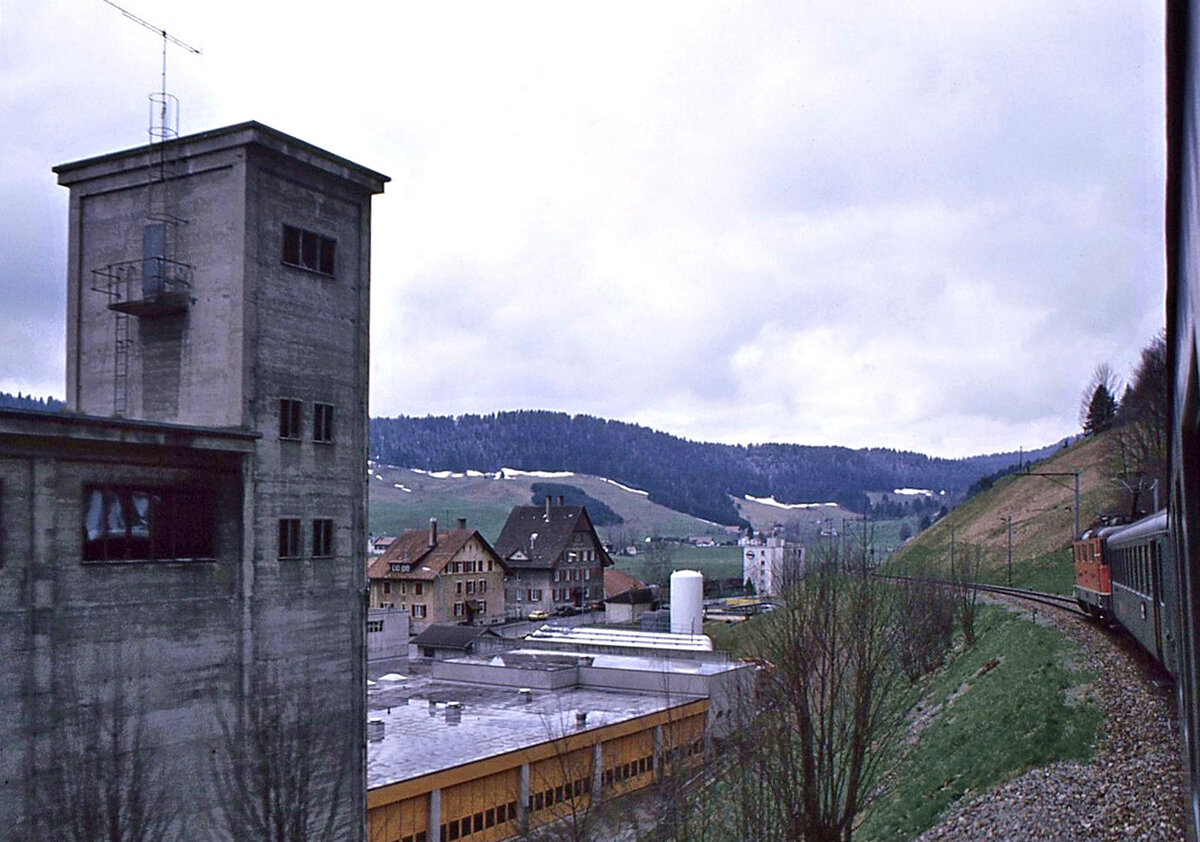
left=83, top=486, right=216, bottom=561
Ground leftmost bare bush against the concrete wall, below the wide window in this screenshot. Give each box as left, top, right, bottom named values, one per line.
left=25, top=657, right=184, bottom=842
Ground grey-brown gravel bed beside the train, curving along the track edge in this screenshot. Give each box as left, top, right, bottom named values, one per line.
left=918, top=609, right=1184, bottom=842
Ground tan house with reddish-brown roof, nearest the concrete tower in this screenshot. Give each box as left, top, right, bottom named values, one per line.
left=367, top=518, right=505, bottom=633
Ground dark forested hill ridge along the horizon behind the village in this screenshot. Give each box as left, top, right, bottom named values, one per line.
left=371, top=410, right=1054, bottom=524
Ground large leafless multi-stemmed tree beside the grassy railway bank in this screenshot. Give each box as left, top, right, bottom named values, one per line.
left=700, top=559, right=906, bottom=842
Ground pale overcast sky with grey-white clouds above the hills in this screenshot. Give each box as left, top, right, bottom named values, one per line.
left=0, top=0, right=1164, bottom=456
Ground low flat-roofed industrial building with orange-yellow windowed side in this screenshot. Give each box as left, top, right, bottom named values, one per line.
left=367, top=630, right=754, bottom=842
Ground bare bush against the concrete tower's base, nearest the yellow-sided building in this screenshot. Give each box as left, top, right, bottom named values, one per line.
left=214, top=667, right=353, bottom=842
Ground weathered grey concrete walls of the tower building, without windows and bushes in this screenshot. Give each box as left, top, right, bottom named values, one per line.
left=19, top=124, right=385, bottom=840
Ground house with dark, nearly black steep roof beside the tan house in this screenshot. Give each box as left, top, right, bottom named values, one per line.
left=496, top=497, right=612, bottom=615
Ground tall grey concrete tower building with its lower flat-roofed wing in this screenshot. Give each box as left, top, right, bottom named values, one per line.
left=0, top=122, right=388, bottom=840
